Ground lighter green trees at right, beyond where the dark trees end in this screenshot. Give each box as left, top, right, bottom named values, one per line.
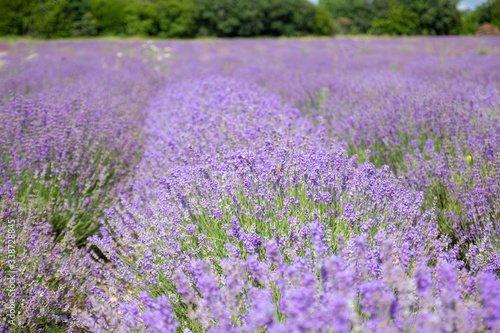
left=319, top=0, right=500, bottom=36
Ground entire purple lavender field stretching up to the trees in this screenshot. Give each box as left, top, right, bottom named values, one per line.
left=0, top=37, right=500, bottom=332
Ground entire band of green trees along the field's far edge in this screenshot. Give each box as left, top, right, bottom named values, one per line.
left=0, top=0, right=500, bottom=38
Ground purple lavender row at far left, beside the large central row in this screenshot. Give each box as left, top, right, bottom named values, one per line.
left=0, top=43, right=162, bottom=331
